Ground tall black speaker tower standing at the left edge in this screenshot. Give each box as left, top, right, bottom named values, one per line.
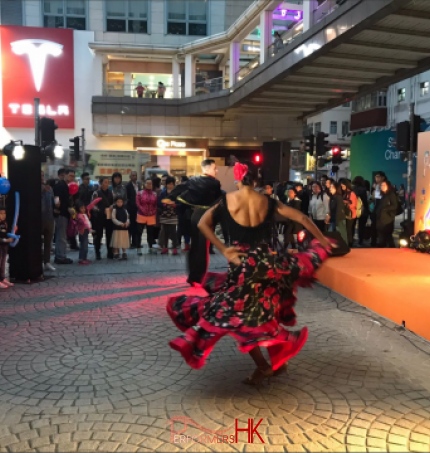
left=7, top=145, right=43, bottom=281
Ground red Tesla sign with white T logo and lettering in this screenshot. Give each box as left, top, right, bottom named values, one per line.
left=0, top=26, right=75, bottom=129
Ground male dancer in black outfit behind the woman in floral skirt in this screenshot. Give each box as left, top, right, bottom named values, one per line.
left=169, top=159, right=221, bottom=286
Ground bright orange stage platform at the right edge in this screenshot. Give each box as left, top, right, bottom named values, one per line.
left=318, top=249, right=430, bottom=340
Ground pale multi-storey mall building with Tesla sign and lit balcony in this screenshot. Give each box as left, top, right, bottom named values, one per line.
left=0, top=0, right=324, bottom=180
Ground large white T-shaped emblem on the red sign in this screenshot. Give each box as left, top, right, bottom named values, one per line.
left=10, top=39, right=63, bottom=92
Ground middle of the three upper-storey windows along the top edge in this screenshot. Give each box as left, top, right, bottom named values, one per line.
left=106, top=0, right=148, bottom=33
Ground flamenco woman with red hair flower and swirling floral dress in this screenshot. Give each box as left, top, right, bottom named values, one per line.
left=167, top=163, right=331, bottom=385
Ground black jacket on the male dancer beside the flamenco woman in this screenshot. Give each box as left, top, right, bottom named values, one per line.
left=177, top=175, right=221, bottom=209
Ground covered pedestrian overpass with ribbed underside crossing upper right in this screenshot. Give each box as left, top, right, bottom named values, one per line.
left=92, top=0, right=430, bottom=138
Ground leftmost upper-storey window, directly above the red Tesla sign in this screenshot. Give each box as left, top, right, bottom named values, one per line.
left=43, top=0, right=87, bottom=30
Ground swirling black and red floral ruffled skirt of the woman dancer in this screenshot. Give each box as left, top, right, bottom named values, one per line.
left=167, top=240, right=328, bottom=370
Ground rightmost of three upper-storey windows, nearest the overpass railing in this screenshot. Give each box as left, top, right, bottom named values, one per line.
left=165, top=0, right=207, bottom=36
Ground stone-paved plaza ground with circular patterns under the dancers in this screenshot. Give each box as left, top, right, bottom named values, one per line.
left=0, top=252, right=430, bottom=453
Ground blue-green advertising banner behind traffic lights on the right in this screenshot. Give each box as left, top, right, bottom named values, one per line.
left=350, top=131, right=407, bottom=187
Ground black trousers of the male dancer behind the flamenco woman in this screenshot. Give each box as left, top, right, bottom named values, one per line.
left=187, top=208, right=209, bottom=284
